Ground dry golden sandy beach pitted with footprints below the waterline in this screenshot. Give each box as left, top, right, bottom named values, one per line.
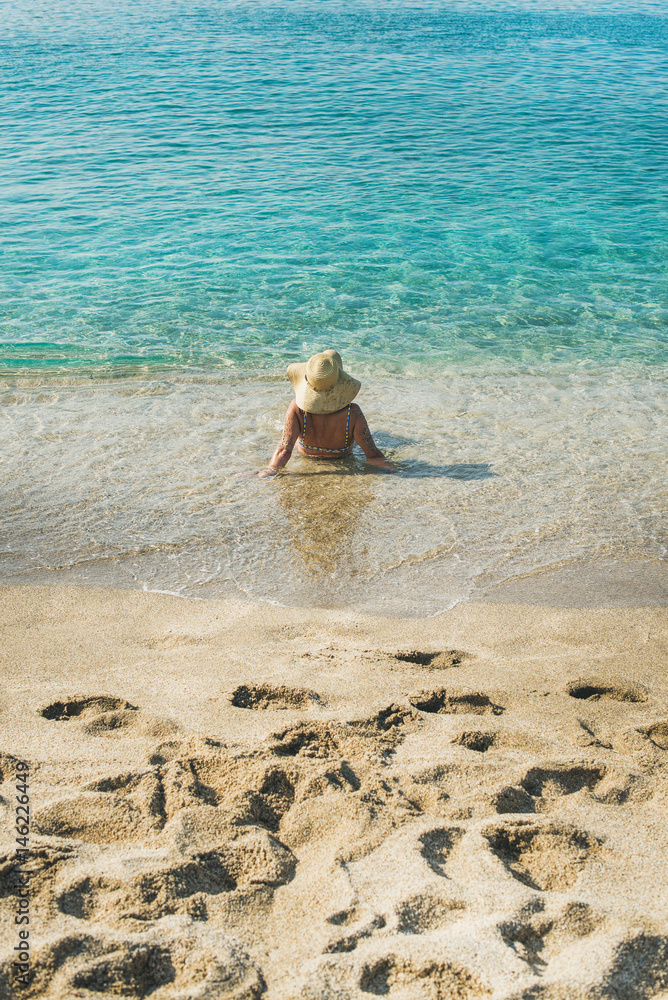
left=0, top=586, right=668, bottom=1000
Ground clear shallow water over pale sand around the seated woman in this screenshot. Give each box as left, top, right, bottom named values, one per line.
left=0, top=367, right=668, bottom=616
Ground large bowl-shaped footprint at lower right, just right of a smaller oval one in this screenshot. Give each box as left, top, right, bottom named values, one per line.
left=484, top=821, right=602, bottom=892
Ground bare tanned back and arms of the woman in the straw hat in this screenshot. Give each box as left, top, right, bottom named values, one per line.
left=258, top=399, right=397, bottom=478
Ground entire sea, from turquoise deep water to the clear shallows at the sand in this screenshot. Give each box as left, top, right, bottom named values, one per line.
left=0, top=0, right=668, bottom=616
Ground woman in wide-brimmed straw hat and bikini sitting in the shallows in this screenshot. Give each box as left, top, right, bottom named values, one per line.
left=258, top=351, right=397, bottom=476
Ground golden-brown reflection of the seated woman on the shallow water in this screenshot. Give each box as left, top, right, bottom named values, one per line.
left=276, top=462, right=373, bottom=580
